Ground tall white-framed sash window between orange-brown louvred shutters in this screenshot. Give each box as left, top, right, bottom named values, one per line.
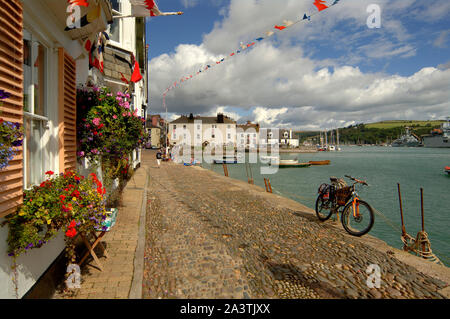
left=23, top=30, right=48, bottom=188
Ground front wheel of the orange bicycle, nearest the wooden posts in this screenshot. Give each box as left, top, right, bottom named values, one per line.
left=341, top=200, right=374, bottom=237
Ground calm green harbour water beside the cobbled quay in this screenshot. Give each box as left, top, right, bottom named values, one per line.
left=202, top=146, right=450, bottom=266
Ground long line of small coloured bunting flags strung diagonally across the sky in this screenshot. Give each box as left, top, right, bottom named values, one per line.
left=160, top=0, right=340, bottom=98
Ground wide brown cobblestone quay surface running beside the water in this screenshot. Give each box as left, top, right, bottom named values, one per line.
left=143, top=151, right=446, bottom=299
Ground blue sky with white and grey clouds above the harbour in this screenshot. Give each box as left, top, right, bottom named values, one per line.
left=147, top=0, right=450, bottom=130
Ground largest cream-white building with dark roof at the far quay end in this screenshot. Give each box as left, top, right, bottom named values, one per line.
left=169, top=114, right=236, bottom=147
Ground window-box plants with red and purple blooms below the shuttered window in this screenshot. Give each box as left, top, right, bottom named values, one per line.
left=2, top=171, right=106, bottom=261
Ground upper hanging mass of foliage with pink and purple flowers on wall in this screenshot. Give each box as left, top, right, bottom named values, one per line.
left=77, top=88, right=147, bottom=192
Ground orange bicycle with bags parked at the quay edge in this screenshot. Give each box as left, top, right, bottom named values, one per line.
left=316, top=175, right=374, bottom=237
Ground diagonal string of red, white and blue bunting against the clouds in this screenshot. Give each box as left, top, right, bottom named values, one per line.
left=163, top=0, right=340, bottom=102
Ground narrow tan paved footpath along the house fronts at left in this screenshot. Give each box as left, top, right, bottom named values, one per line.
left=54, top=161, right=147, bottom=299
